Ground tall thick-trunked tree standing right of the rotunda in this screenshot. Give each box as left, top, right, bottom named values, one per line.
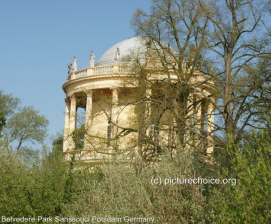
left=199, top=0, right=271, bottom=151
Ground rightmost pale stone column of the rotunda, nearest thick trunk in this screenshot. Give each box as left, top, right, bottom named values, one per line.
left=207, top=102, right=214, bottom=154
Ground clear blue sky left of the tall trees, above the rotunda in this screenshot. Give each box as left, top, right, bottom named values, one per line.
left=0, top=0, right=151, bottom=140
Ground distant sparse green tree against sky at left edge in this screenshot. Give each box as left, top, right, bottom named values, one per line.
left=0, top=93, right=49, bottom=151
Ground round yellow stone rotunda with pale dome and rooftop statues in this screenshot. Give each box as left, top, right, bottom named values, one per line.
left=63, top=37, right=215, bottom=162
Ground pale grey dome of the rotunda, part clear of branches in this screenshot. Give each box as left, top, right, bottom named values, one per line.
left=95, top=37, right=146, bottom=66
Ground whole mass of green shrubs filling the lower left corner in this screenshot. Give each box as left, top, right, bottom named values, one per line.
left=0, top=136, right=78, bottom=217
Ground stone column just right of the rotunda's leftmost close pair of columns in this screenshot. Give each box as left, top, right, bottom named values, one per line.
left=84, top=90, right=93, bottom=150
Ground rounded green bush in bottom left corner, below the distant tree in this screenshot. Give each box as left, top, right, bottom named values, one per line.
left=0, top=150, right=35, bottom=217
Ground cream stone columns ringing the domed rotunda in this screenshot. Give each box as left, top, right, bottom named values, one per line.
left=63, top=88, right=214, bottom=154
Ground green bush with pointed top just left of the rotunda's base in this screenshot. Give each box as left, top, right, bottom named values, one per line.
left=30, top=136, right=68, bottom=216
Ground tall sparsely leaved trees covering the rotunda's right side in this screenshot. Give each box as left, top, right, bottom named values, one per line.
left=131, top=0, right=271, bottom=154
